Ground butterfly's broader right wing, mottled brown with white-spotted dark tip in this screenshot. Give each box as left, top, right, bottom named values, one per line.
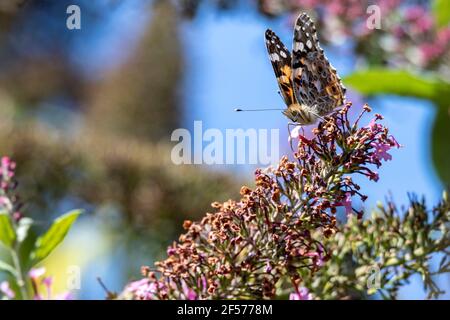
left=292, top=13, right=346, bottom=115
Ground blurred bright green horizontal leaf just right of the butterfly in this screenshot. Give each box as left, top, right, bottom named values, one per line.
left=344, top=68, right=450, bottom=101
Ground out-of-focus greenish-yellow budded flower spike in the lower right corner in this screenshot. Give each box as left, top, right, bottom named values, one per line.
left=302, top=192, right=450, bottom=299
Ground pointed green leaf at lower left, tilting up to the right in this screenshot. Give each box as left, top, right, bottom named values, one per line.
left=31, top=210, right=82, bottom=265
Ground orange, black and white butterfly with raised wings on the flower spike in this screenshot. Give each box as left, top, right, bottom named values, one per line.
left=265, top=13, right=346, bottom=125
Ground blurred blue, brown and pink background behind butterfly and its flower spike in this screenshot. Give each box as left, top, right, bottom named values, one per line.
left=0, top=0, right=450, bottom=299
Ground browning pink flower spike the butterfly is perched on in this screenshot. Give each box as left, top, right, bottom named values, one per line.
left=122, top=104, right=399, bottom=299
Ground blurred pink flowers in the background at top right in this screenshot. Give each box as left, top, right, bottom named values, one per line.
left=260, top=0, right=450, bottom=71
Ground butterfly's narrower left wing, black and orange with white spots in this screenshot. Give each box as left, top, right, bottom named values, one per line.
left=266, top=29, right=296, bottom=106
